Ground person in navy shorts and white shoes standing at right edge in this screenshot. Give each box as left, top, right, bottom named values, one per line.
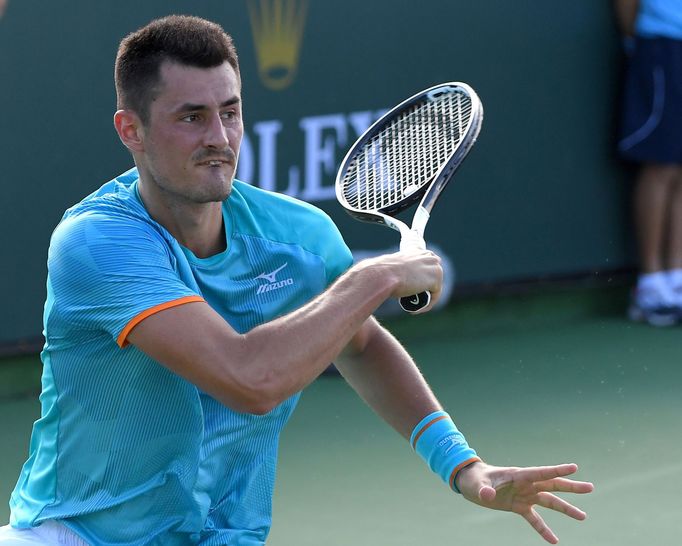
left=615, top=0, right=682, bottom=326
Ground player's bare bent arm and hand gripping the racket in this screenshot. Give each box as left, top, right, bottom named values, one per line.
left=127, top=246, right=442, bottom=414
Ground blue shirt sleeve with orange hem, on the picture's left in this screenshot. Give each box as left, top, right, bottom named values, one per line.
left=48, top=206, right=203, bottom=347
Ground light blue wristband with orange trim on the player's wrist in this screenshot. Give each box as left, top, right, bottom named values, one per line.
left=410, top=411, right=481, bottom=493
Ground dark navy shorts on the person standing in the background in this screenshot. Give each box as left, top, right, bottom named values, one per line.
left=618, top=38, right=682, bottom=164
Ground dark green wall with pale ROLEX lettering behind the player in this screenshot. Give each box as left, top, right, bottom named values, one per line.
left=0, top=0, right=633, bottom=344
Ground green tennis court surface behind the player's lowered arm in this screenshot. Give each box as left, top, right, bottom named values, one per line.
left=0, top=289, right=682, bottom=546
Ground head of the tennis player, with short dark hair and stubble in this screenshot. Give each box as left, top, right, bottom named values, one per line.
left=114, top=16, right=244, bottom=206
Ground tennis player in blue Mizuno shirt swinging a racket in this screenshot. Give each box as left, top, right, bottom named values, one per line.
left=0, top=16, right=592, bottom=546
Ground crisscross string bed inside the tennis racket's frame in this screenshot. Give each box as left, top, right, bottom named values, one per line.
left=342, top=92, right=472, bottom=210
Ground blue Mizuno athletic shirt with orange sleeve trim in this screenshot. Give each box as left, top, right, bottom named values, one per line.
left=10, top=169, right=352, bottom=546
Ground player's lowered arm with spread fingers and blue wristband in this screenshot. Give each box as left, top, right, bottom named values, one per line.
left=336, top=317, right=593, bottom=544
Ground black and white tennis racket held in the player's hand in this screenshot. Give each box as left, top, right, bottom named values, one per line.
left=336, top=82, right=483, bottom=313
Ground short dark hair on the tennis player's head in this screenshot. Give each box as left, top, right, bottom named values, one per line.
left=114, top=15, right=239, bottom=124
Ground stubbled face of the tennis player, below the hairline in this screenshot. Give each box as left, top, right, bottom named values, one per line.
left=139, top=63, right=243, bottom=205
